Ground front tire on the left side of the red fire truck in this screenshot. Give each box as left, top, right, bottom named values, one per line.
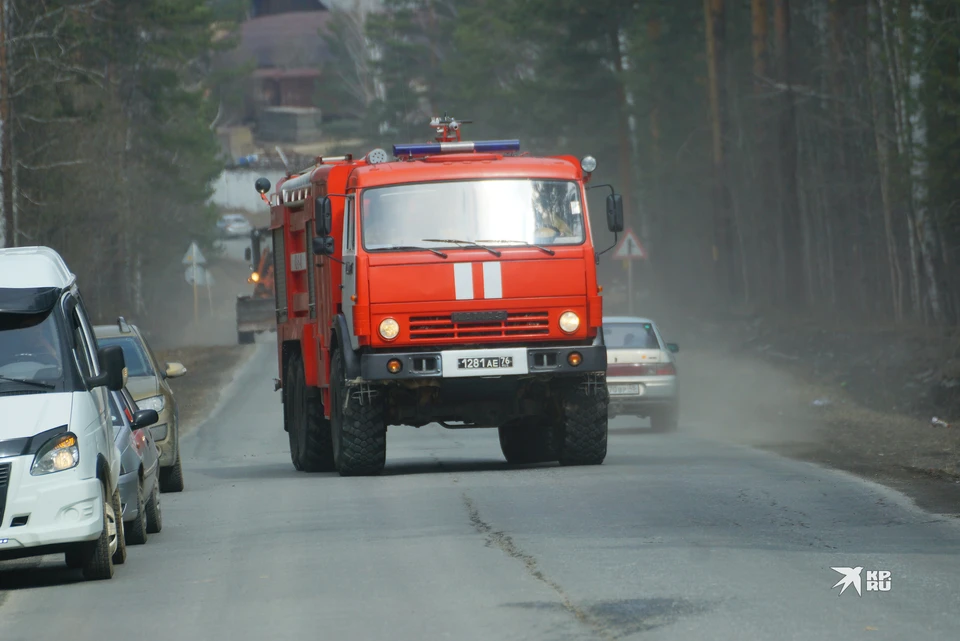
left=330, top=350, right=387, bottom=476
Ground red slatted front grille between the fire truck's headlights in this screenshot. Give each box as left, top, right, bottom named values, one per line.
left=410, top=312, right=550, bottom=341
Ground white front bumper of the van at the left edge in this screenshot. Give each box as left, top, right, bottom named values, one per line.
left=0, top=457, right=103, bottom=559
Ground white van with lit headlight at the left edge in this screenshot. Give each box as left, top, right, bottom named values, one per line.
left=0, top=247, right=126, bottom=579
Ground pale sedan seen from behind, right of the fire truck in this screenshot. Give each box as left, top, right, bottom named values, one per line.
left=603, top=316, right=680, bottom=432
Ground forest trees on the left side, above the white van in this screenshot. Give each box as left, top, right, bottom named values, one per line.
left=0, top=0, right=245, bottom=318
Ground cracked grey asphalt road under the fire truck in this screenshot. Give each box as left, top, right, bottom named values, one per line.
left=0, top=340, right=960, bottom=641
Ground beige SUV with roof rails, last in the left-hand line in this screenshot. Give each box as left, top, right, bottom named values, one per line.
left=93, top=316, right=187, bottom=492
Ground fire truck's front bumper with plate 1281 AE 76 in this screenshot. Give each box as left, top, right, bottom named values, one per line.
left=360, top=345, right=607, bottom=382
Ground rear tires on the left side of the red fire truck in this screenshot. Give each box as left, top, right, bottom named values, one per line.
left=290, top=357, right=334, bottom=472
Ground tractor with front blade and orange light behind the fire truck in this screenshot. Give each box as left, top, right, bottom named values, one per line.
left=237, top=227, right=277, bottom=345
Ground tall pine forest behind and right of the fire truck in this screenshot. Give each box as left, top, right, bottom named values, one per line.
left=319, top=0, right=960, bottom=325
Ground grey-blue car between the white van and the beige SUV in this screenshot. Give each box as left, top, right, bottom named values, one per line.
left=110, top=388, right=163, bottom=545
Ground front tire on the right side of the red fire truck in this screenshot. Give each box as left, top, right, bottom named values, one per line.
left=558, top=385, right=608, bottom=465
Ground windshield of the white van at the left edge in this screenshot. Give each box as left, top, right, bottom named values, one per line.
left=0, top=312, right=64, bottom=387
